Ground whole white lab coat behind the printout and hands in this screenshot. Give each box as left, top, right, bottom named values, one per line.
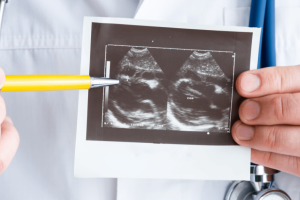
left=0, top=0, right=300, bottom=200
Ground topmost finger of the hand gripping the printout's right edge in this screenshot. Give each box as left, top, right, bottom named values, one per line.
left=236, top=65, right=300, bottom=98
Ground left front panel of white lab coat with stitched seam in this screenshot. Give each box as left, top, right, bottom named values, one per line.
left=0, top=0, right=138, bottom=200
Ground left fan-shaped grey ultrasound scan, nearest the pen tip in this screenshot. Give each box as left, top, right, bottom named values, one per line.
left=104, top=48, right=168, bottom=130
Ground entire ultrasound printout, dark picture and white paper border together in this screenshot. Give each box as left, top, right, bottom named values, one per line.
left=74, top=17, right=260, bottom=180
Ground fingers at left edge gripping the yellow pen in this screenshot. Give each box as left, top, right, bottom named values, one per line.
left=0, top=68, right=20, bottom=174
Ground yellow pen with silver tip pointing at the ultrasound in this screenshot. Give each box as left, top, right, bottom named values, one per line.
left=1, top=75, right=119, bottom=92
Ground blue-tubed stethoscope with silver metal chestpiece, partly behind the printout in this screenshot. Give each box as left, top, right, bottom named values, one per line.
left=0, top=0, right=291, bottom=200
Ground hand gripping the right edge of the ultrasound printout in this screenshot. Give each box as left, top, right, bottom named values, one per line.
left=232, top=66, right=300, bottom=176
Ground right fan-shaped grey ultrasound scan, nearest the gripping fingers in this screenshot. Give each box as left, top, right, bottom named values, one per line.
left=167, top=51, right=232, bottom=132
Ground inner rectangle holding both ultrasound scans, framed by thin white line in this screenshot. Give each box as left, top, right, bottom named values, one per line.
left=101, top=44, right=235, bottom=132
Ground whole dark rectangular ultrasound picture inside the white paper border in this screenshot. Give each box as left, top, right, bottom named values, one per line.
left=86, top=23, right=253, bottom=145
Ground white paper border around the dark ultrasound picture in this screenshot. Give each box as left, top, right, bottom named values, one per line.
left=74, top=17, right=260, bottom=180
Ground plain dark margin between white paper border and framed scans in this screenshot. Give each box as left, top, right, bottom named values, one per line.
left=86, top=23, right=252, bottom=145
